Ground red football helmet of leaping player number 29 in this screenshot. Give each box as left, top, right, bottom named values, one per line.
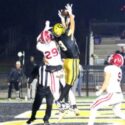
left=39, top=30, right=53, bottom=43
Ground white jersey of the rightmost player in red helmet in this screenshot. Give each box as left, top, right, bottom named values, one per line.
left=104, top=65, right=122, bottom=92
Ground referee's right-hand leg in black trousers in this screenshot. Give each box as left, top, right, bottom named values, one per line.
left=43, top=88, right=53, bottom=124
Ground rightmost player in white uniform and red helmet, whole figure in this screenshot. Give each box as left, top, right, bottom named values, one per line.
left=88, top=54, right=125, bottom=125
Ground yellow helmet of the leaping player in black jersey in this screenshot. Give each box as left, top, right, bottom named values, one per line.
left=52, top=23, right=65, bottom=36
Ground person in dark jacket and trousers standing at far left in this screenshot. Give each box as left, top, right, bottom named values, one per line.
left=8, top=61, right=23, bottom=100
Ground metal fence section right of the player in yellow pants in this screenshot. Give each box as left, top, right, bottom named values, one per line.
left=83, top=66, right=125, bottom=96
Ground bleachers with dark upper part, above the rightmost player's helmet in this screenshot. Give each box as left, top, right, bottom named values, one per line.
left=91, top=22, right=125, bottom=65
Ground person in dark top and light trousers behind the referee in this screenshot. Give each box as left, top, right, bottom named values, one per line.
left=27, top=56, right=37, bottom=99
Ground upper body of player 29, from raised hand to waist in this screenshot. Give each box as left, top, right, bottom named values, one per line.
left=36, top=21, right=62, bottom=66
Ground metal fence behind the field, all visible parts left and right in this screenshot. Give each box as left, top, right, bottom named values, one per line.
left=0, top=66, right=125, bottom=98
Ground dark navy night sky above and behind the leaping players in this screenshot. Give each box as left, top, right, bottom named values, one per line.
left=0, top=0, right=125, bottom=63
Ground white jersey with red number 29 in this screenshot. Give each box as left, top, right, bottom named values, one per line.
left=36, top=41, right=62, bottom=66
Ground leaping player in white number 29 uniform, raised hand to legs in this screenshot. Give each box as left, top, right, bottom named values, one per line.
left=36, top=21, right=64, bottom=100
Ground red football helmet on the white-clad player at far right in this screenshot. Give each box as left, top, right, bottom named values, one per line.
left=108, top=54, right=124, bottom=67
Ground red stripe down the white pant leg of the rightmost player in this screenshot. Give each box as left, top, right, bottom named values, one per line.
left=91, top=93, right=113, bottom=108
